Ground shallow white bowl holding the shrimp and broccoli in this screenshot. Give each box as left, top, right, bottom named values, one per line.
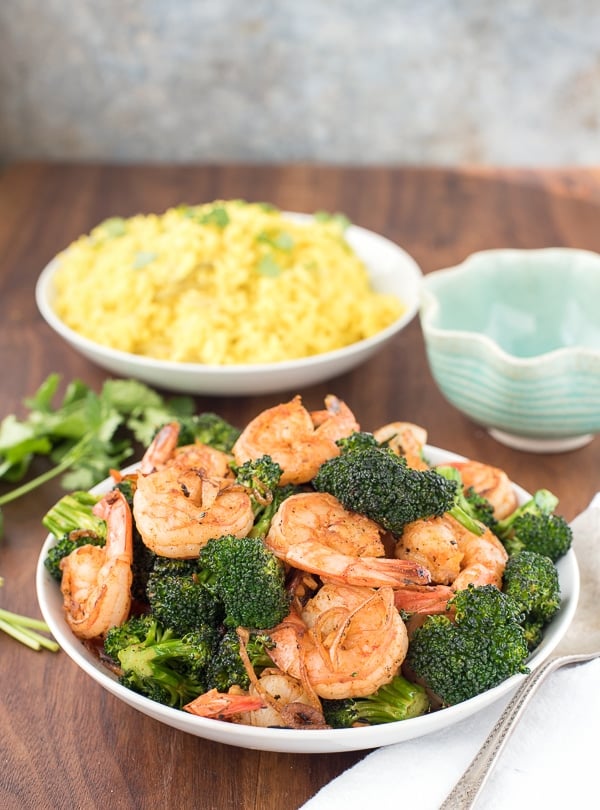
left=36, top=446, right=579, bottom=754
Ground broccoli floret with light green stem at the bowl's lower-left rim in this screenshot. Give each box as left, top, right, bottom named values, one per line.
left=104, top=618, right=216, bottom=708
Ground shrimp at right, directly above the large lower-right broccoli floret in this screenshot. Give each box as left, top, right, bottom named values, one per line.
left=395, top=514, right=508, bottom=613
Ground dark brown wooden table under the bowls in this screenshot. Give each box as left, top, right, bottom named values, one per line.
left=0, top=163, right=600, bottom=810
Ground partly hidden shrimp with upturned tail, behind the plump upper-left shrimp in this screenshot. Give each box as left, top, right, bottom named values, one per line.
left=139, top=422, right=234, bottom=478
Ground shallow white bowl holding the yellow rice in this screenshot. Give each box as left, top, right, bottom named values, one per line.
left=35, top=212, right=421, bottom=395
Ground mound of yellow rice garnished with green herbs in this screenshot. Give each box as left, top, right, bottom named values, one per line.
left=54, top=200, right=403, bottom=365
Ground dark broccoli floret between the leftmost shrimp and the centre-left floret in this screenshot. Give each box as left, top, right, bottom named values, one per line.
left=146, top=556, right=223, bottom=635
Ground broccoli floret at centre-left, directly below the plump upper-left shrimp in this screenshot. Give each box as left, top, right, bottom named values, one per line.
left=199, top=535, right=289, bottom=629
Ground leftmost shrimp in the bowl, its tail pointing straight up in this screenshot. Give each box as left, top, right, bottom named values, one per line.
left=61, top=490, right=133, bottom=639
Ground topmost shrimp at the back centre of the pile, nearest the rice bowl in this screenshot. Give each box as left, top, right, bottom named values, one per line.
left=233, top=395, right=360, bottom=485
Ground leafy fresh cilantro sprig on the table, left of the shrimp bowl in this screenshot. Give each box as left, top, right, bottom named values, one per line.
left=0, top=374, right=194, bottom=534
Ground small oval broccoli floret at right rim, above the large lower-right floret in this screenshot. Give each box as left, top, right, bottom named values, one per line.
left=502, top=551, right=560, bottom=627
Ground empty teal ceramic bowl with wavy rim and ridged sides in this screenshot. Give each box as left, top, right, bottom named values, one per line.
left=420, top=248, right=600, bottom=452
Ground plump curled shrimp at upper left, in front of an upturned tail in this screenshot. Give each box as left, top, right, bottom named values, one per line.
left=133, top=464, right=254, bottom=559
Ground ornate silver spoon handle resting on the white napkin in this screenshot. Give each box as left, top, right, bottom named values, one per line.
left=439, top=651, right=600, bottom=810
